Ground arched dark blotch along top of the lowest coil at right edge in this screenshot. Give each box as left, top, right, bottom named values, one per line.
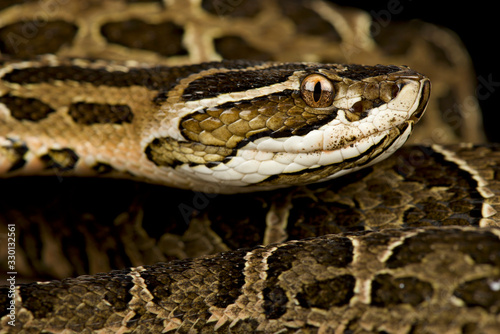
left=387, top=229, right=500, bottom=268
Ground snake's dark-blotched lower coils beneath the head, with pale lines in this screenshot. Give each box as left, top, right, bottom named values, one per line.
left=1, top=145, right=500, bottom=333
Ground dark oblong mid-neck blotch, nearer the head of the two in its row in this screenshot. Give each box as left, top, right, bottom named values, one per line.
left=68, top=102, right=134, bottom=125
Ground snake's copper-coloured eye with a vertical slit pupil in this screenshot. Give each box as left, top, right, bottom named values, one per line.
left=300, top=74, right=335, bottom=108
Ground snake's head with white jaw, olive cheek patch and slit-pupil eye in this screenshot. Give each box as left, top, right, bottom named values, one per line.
left=145, top=63, right=430, bottom=193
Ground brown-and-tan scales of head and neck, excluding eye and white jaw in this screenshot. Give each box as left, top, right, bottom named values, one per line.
left=0, top=55, right=418, bottom=188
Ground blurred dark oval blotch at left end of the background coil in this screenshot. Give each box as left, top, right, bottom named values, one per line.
left=0, top=20, right=78, bottom=58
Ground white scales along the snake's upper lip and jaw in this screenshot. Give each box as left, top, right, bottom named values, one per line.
left=180, top=80, right=420, bottom=186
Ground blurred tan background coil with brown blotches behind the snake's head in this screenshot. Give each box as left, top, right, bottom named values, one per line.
left=0, top=0, right=484, bottom=143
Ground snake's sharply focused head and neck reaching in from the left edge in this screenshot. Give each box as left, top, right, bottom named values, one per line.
left=0, top=56, right=430, bottom=193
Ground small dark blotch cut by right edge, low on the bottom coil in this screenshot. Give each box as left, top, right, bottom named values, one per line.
left=453, top=277, right=500, bottom=314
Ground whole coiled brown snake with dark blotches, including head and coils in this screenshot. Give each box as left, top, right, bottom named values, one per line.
left=0, top=0, right=500, bottom=333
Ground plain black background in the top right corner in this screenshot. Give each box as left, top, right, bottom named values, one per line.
left=332, top=0, right=500, bottom=142
